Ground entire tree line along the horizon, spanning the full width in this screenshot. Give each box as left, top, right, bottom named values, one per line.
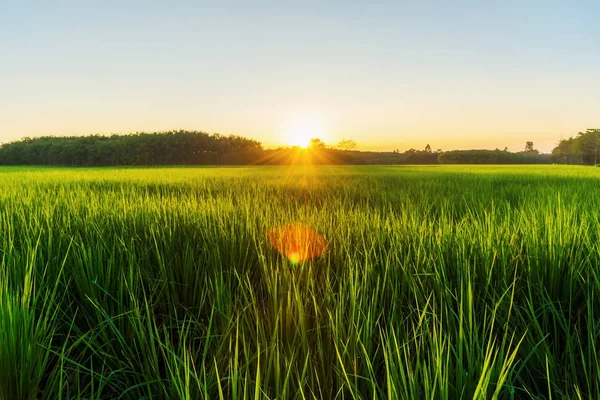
left=0, top=129, right=600, bottom=167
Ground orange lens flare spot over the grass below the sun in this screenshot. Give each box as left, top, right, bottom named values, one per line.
left=267, top=224, right=327, bottom=264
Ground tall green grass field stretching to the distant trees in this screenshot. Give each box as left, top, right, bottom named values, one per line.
left=0, top=166, right=600, bottom=400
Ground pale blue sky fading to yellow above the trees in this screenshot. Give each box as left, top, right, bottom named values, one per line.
left=0, top=0, right=600, bottom=152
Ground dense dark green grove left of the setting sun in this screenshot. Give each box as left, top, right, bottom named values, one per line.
left=0, top=131, right=263, bottom=166
